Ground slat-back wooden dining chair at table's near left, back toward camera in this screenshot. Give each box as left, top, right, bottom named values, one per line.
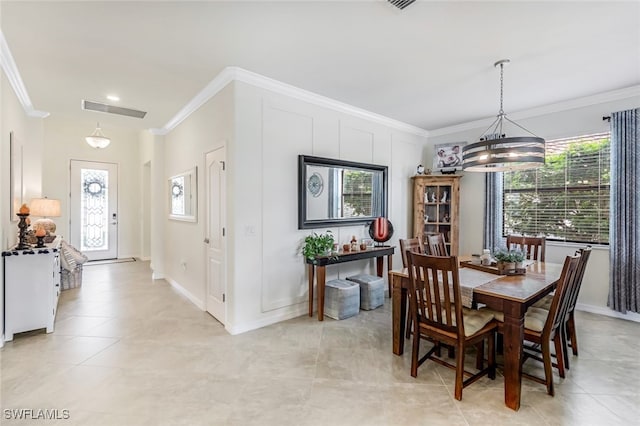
left=407, top=252, right=497, bottom=400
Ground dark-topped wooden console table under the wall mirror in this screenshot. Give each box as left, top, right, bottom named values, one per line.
left=306, top=246, right=395, bottom=321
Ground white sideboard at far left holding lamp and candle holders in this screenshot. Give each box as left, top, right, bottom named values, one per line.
left=2, top=237, right=61, bottom=341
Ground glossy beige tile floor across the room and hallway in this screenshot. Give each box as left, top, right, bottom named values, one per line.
left=0, top=262, right=640, bottom=426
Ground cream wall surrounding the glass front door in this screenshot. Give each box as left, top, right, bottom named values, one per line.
left=42, top=114, right=142, bottom=257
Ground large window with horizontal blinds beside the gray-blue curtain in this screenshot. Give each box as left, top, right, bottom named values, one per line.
left=503, top=132, right=611, bottom=244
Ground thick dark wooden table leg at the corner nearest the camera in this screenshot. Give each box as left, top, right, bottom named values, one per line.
left=503, top=300, right=526, bottom=410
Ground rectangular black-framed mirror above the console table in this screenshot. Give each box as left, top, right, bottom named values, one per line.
left=298, top=155, right=387, bottom=229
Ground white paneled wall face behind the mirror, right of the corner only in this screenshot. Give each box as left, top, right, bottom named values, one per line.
left=229, top=83, right=425, bottom=332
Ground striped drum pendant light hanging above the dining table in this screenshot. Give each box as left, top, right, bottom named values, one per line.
left=462, top=59, right=545, bottom=172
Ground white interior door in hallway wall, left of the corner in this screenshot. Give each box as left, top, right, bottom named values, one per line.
left=204, top=147, right=227, bottom=324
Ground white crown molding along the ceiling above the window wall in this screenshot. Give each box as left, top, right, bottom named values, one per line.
left=429, top=85, right=640, bottom=136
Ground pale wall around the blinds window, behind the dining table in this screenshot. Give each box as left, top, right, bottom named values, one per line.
left=425, top=96, right=640, bottom=313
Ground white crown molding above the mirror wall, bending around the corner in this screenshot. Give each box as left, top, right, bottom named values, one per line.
left=150, top=67, right=429, bottom=137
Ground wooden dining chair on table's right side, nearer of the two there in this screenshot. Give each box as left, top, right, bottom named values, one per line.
left=488, top=255, right=580, bottom=396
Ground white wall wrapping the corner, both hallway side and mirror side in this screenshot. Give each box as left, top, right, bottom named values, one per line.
left=158, top=81, right=426, bottom=334
